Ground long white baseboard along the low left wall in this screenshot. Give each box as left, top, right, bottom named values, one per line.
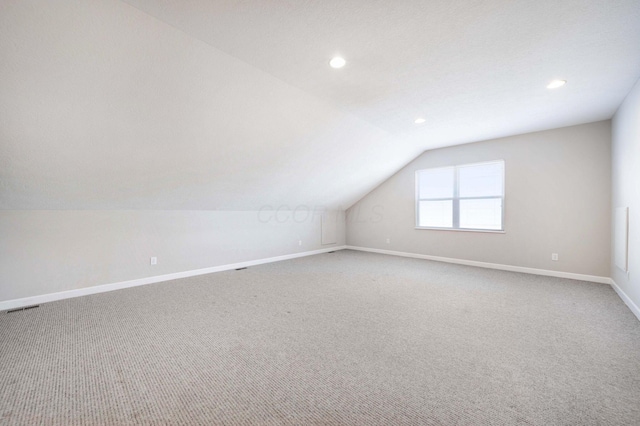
left=0, top=246, right=347, bottom=311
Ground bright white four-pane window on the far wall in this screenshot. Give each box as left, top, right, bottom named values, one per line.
left=416, top=160, right=504, bottom=231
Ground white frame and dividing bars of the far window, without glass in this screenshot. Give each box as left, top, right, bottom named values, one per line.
left=415, top=160, right=506, bottom=234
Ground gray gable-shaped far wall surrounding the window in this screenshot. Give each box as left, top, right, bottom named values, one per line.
left=347, top=121, right=612, bottom=277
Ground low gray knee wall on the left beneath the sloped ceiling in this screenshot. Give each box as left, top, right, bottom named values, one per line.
left=0, top=209, right=345, bottom=301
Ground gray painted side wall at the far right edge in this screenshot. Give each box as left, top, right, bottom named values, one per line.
left=611, top=77, right=640, bottom=306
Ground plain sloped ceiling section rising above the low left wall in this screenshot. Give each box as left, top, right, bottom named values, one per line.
left=0, top=0, right=420, bottom=210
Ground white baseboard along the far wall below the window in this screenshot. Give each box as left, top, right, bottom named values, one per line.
left=347, top=245, right=611, bottom=284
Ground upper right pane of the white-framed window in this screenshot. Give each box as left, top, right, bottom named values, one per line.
left=458, top=162, right=504, bottom=197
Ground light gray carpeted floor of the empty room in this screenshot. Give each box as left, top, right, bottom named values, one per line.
left=0, top=251, right=640, bottom=425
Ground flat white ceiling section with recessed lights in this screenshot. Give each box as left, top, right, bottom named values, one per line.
left=124, top=0, right=640, bottom=140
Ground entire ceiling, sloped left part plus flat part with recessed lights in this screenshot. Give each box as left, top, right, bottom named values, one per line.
left=0, top=0, right=640, bottom=210
